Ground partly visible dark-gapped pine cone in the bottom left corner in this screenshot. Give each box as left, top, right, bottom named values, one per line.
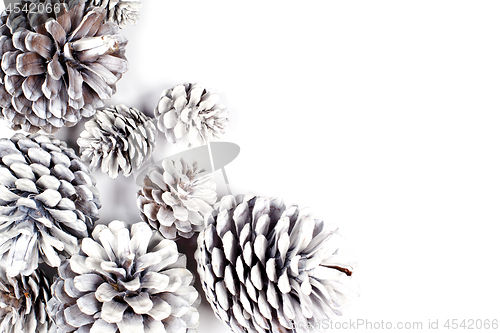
left=0, top=261, right=49, bottom=333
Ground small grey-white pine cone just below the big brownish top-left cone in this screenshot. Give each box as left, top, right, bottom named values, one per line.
left=77, top=104, right=156, bottom=179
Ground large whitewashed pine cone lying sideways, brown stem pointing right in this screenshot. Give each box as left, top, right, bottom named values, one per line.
left=195, top=196, right=355, bottom=333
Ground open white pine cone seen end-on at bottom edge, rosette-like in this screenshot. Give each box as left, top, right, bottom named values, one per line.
left=47, top=221, right=199, bottom=333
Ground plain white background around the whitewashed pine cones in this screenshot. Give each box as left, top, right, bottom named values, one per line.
left=0, top=0, right=500, bottom=332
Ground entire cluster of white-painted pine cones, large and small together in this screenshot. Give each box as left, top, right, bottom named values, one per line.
left=0, top=0, right=356, bottom=333
